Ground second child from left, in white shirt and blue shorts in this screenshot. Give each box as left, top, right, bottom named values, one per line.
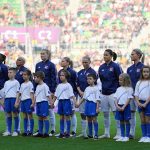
left=16, top=70, right=35, bottom=136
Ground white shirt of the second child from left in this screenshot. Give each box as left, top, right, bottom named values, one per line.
left=19, top=81, right=34, bottom=101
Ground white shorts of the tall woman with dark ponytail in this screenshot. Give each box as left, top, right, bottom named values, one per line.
left=101, top=94, right=116, bottom=112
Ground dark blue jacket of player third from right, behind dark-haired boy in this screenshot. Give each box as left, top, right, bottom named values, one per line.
left=77, top=67, right=97, bottom=92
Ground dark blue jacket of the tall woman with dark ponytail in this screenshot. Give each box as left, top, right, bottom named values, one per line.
left=98, top=61, right=122, bottom=95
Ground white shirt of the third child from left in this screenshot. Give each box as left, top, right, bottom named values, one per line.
left=35, top=83, right=50, bottom=103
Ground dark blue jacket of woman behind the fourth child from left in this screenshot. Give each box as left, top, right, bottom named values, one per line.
left=58, top=67, right=78, bottom=94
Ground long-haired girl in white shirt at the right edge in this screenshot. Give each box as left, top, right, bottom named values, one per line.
left=134, top=66, right=150, bottom=143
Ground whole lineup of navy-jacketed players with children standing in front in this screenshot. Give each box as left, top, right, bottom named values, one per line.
left=0, top=49, right=150, bottom=142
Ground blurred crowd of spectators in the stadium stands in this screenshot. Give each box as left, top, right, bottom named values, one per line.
left=0, top=0, right=150, bottom=71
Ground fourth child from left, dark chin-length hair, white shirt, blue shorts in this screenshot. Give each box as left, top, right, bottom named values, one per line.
left=53, top=69, right=76, bottom=138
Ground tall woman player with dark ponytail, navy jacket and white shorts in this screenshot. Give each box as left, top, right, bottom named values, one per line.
left=98, top=49, right=122, bottom=139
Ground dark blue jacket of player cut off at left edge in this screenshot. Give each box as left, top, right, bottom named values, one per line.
left=0, top=62, right=8, bottom=90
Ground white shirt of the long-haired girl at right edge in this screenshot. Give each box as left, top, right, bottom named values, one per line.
left=134, top=80, right=150, bottom=101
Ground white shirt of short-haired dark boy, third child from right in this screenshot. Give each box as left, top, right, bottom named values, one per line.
left=83, top=86, right=101, bottom=103
